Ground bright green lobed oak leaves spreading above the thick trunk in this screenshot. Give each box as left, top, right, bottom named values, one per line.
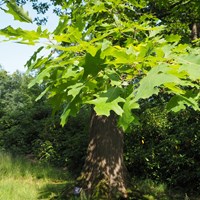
left=1, top=1, right=199, bottom=130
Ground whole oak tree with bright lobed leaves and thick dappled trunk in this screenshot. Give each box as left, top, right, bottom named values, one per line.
left=0, top=0, right=200, bottom=199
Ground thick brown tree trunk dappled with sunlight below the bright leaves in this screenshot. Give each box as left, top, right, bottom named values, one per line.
left=81, top=111, right=127, bottom=199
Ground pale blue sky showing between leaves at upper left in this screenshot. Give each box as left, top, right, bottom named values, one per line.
left=0, top=3, right=58, bottom=73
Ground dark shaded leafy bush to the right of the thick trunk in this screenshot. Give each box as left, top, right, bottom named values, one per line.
left=125, top=101, right=200, bottom=192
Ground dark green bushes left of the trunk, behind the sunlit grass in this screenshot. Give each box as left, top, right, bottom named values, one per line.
left=0, top=70, right=90, bottom=173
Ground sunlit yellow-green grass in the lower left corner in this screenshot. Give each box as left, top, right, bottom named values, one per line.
left=0, top=152, right=71, bottom=200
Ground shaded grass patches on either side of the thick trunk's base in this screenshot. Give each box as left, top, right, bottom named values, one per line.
left=38, top=177, right=200, bottom=200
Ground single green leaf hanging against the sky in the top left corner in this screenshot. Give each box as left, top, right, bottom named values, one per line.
left=4, top=0, right=32, bottom=23
